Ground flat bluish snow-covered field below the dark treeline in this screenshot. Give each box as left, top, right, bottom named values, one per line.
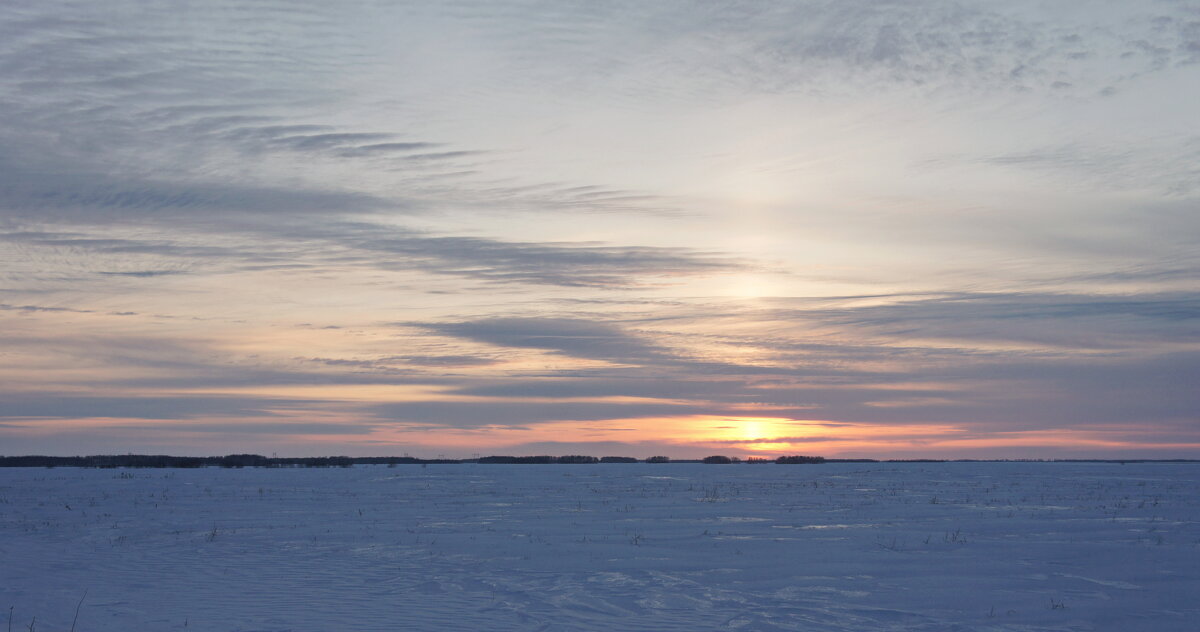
left=0, top=463, right=1200, bottom=632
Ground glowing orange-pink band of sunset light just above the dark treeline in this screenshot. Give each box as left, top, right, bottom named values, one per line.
left=6, top=407, right=1200, bottom=458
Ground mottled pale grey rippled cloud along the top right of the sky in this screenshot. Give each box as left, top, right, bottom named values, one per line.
left=446, top=0, right=1196, bottom=98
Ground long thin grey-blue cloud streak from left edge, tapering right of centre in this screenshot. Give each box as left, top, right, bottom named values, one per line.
left=0, top=223, right=750, bottom=289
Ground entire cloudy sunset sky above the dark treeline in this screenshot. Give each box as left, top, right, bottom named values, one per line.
left=0, top=0, right=1200, bottom=458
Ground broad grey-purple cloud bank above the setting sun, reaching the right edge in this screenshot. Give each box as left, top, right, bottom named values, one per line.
left=408, top=293, right=1200, bottom=431
